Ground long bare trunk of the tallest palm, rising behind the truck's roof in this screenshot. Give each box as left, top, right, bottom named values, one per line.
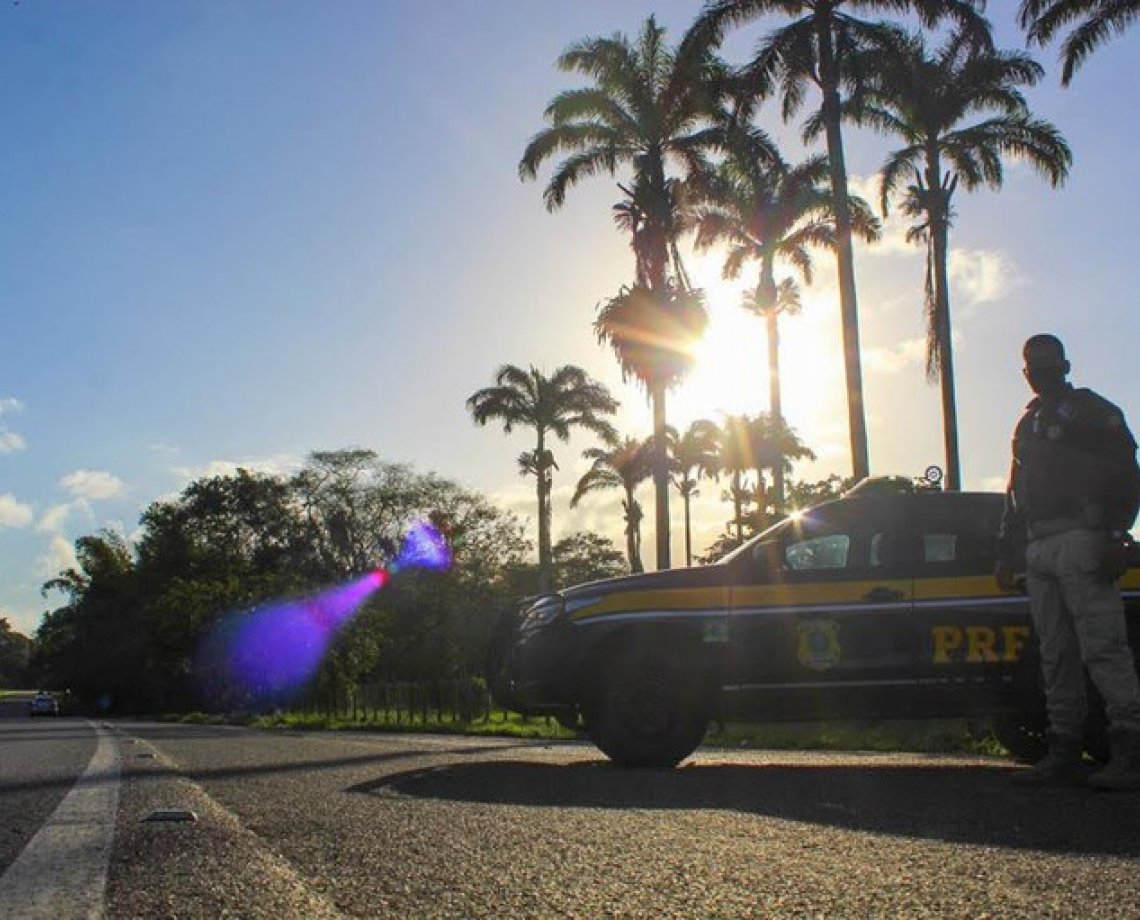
left=816, top=19, right=870, bottom=480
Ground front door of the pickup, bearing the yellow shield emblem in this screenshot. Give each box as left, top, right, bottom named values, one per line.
left=730, top=496, right=915, bottom=718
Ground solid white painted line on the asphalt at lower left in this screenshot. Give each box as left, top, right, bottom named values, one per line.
left=0, top=722, right=119, bottom=920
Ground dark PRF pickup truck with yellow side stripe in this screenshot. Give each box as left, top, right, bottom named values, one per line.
left=490, top=482, right=1140, bottom=767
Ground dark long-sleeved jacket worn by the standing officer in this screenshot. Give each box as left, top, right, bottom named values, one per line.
left=1001, top=383, right=1140, bottom=546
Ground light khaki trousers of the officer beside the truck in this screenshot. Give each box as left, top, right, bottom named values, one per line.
left=1026, top=530, right=1140, bottom=738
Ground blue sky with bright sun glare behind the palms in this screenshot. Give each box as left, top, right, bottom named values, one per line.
left=0, top=0, right=1140, bottom=634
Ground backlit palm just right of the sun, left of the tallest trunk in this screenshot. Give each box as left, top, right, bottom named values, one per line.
left=693, top=131, right=879, bottom=512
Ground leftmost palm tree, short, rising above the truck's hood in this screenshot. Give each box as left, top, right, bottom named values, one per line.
left=467, top=364, right=618, bottom=592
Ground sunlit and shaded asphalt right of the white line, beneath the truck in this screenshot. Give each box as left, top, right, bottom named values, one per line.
left=3, top=723, right=1140, bottom=918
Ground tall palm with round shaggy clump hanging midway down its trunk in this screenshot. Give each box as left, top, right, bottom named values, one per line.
left=519, top=16, right=723, bottom=569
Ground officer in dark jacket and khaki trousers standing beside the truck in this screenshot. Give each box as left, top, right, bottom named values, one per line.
left=996, top=335, right=1140, bottom=789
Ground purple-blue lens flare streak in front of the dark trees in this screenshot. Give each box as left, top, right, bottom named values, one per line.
left=195, top=522, right=451, bottom=707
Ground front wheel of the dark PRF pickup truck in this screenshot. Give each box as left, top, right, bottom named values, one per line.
left=586, top=648, right=709, bottom=768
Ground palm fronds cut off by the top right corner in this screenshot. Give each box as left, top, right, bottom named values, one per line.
left=1018, top=0, right=1140, bottom=87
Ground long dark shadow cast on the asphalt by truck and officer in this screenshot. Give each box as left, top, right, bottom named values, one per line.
left=349, top=762, right=1140, bottom=856
